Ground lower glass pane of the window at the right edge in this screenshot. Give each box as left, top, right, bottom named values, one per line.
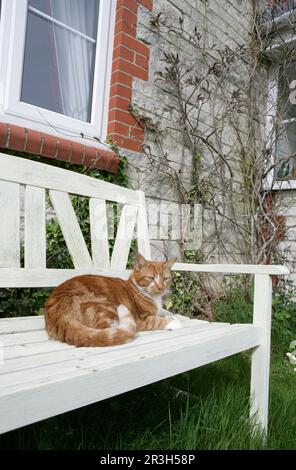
left=276, top=122, right=296, bottom=179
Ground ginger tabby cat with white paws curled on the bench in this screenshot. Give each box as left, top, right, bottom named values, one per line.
left=45, top=254, right=181, bottom=346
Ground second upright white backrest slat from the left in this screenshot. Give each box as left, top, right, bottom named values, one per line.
left=25, top=186, right=46, bottom=269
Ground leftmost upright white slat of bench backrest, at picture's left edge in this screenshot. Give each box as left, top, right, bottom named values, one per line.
left=0, top=181, right=20, bottom=268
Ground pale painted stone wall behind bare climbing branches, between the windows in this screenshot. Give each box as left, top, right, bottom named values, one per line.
left=119, top=0, right=253, bottom=262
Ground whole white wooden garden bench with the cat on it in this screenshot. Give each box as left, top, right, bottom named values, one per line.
left=0, top=154, right=288, bottom=433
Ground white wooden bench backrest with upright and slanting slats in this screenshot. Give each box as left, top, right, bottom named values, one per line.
left=0, top=153, right=150, bottom=287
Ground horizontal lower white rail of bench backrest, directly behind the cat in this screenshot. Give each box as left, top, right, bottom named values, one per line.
left=0, top=268, right=130, bottom=287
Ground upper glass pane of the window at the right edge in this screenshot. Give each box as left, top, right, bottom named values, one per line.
left=279, top=61, right=296, bottom=120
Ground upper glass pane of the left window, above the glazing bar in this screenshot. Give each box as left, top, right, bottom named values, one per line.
left=29, top=0, right=100, bottom=39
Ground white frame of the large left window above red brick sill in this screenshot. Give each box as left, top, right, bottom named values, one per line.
left=0, top=0, right=116, bottom=147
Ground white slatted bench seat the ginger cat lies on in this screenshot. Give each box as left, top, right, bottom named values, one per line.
left=0, top=315, right=261, bottom=432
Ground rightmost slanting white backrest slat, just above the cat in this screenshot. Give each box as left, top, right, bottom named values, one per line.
left=111, top=204, right=138, bottom=271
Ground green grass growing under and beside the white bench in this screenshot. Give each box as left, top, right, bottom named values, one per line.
left=0, top=284, right=296, bottom=450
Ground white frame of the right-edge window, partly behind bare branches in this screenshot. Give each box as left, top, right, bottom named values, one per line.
left=263, top=10, right=296, bottom=190
